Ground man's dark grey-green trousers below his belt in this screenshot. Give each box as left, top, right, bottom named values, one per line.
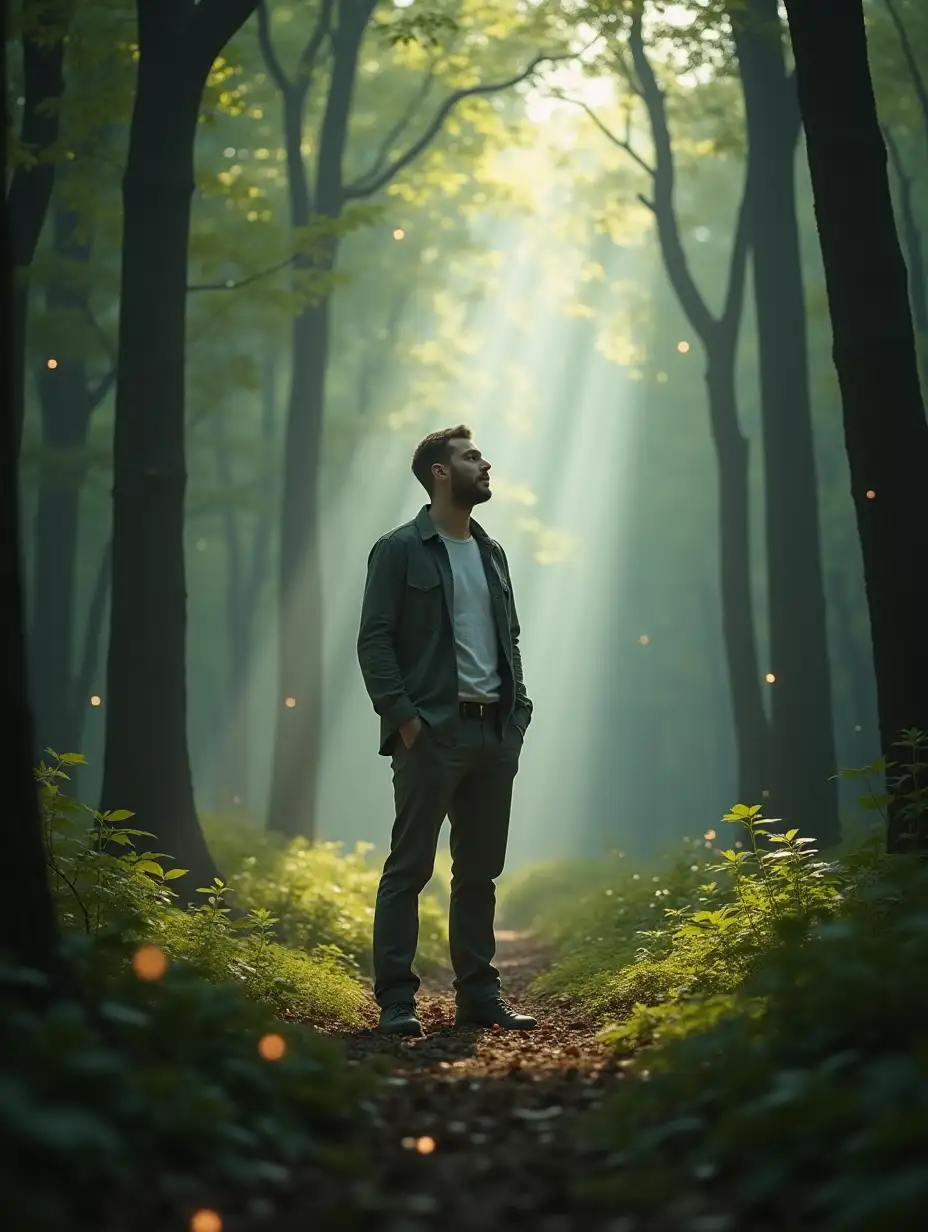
left=373, top=717, right=523, bottom=1007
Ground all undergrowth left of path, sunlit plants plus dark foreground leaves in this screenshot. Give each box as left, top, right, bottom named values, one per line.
left=0, top=750, right=372, bottom=1232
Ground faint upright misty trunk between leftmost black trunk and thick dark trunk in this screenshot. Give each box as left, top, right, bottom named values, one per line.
left=31, top=206, right=91, bottom=753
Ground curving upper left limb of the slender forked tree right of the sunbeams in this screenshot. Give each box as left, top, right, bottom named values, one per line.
left=629, top=14, right=718, bottom=344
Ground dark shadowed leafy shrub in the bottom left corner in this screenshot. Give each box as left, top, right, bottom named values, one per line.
left=0, top=933, right=365, bottom=1232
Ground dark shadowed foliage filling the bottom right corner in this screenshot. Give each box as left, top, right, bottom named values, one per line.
left=581, top=859, right=928, bottom=1232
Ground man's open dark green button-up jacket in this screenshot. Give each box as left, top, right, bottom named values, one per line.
left=357, top=505, right=531, bottom=755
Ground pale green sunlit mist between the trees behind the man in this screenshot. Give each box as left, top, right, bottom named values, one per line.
left=23, top=5, right=924, bottom=869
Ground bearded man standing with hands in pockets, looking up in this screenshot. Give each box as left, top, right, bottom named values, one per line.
left=357, top=424, right=535, bottom=1035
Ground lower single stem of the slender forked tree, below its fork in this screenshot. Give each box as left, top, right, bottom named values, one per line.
left=706, top=352, right=770, bottom=804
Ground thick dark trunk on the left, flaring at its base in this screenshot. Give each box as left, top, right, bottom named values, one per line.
left=102, top=0, right=255, bottom=887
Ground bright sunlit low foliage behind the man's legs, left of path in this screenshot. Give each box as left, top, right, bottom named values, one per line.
left=203, top=816, right=447, bottom=973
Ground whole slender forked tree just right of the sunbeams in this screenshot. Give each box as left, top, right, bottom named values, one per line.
left=626, top=17, right=770, bottom=803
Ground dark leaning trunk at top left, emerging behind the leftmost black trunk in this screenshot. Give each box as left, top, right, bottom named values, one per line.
left=4, top=0, right=74, bottom=455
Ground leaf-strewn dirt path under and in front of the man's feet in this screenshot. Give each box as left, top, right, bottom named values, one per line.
left=257, top=933, right=627, bottom=1232
